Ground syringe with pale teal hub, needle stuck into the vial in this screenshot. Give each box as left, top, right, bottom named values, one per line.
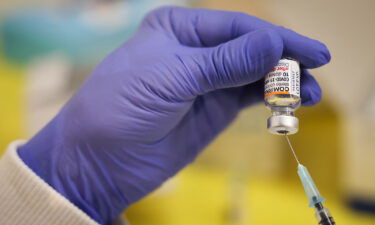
left=285, top=134, right=336, bottom=225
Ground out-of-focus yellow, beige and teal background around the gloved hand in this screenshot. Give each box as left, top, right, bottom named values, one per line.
left=0, top=0, right=375, bottom=225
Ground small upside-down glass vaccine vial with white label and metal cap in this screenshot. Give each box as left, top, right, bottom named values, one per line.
left=264, top=58, right=301, bottom=135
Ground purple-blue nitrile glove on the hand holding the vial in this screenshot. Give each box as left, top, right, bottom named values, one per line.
left=19, top=7, right=330, bottom=224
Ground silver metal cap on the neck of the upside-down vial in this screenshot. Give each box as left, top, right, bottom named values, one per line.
left=267, top=115, right=299, bottom=135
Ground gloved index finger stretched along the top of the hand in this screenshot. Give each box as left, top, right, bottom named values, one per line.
left=143, top=7, right=330, bottom=68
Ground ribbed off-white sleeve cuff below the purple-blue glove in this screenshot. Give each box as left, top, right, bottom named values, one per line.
left=0, top=141, right=97, bottom=225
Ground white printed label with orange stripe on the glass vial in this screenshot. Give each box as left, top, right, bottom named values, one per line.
left=264, top=59, right=300, bottom=98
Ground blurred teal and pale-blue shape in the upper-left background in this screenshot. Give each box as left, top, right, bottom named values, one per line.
left=0, top=0, right=186, bottom=64
